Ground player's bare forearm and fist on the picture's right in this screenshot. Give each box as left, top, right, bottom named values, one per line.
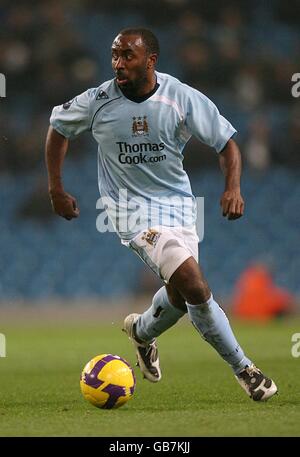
left=220, top=139, right=244, bottom=220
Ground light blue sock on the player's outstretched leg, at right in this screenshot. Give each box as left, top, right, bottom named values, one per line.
left=187, top=295, right=252, bottom=374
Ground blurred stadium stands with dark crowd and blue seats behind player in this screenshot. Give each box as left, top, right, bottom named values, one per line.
left=0, top=0, right=300, bottom=307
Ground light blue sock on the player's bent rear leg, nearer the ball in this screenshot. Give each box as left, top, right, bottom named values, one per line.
left=135, top=287, right=185, bottom=342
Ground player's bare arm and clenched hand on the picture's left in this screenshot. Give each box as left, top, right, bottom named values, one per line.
left=45, top=126, right=79, bottom=220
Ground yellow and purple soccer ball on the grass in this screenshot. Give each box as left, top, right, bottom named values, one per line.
left=80, top=354, right=135, bottom=409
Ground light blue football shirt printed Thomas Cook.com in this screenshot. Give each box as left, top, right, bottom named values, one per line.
left=50, top=72, right=236, bottom=240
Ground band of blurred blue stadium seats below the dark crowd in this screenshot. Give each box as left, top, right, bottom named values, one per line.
left=0, top=159, right=300, bottom=300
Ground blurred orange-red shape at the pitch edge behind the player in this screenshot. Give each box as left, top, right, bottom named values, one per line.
left=232, top=264, right=293, bottom=320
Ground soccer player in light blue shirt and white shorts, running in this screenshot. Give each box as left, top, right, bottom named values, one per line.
left=46, top=28, right=277, bottom=401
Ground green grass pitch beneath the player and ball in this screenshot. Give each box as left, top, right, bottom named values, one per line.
left=0, top=312, right=300, bottom=437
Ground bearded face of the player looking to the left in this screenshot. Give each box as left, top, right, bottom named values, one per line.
left=112, top=35, right=156, bottom=94
